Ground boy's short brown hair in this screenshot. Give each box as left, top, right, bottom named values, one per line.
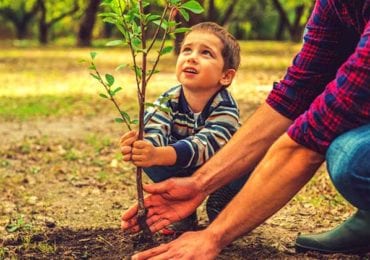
left=185, top=22, right=240, bottom=70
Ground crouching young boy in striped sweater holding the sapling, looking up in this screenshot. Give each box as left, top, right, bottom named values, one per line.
left=121, top=22, right=241, bottom=232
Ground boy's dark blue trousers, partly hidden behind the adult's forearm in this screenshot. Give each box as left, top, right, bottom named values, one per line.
left=143, top=166, right=249, bottom=192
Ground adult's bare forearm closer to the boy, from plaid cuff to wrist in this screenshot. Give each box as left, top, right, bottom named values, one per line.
left=193, top=103, right=292, bottom=194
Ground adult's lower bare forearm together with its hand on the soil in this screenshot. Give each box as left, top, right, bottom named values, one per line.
left=133, top=134, right=324, bottom=259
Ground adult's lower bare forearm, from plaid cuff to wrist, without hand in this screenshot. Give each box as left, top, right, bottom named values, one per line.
left=209, top=134, right=324, bottom=248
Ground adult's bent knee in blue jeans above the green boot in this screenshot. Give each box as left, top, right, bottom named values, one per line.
left=326, top=124, right=370, bottom=210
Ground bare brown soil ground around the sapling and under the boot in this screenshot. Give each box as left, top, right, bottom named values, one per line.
left=0, top=116, right=370, bottom=259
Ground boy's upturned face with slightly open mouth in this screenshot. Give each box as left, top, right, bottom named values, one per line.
left=176, top=31, right=231, bottom=91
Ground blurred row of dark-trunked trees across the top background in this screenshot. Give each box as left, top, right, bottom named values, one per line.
left=0, top=0, right=314, bottom=46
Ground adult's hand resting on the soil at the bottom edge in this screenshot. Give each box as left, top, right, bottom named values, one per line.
left=132, top=230, right=221, bottom=260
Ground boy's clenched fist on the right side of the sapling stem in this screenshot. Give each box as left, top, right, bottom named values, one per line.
left=131, top=140, right=158, bottom=167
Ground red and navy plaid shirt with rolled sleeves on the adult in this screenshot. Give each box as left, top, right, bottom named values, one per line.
left=266, top=0, right=370, bottom=154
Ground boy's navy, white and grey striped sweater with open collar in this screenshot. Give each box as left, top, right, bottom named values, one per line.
left=144, top=85, right=240, bottom=168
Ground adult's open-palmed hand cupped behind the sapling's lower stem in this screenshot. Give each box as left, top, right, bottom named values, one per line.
left=121, top=177, right=207, bottom=232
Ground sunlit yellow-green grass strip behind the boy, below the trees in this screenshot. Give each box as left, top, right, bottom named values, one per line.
left=0, top=42, right=299, bottom=120
